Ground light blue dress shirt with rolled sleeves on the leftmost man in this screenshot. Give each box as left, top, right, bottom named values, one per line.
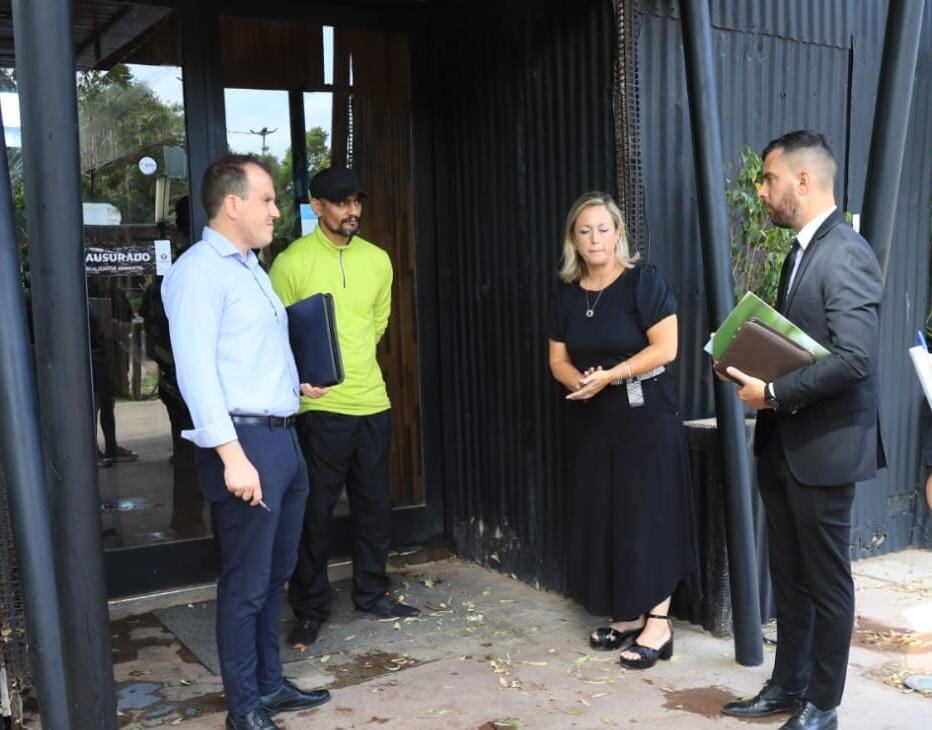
left=162, top=227, right=299, bottom=448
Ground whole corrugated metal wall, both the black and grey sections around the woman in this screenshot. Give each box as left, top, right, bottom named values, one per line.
left=415, top=0, right=932, bottom=588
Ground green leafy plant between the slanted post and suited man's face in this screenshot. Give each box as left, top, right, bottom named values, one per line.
left=725, top=145, right=794, bottom=303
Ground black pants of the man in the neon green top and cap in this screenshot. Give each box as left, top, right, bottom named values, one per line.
left=288, top=411, right=392, bottom=622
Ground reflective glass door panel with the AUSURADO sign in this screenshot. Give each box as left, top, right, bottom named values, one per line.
left=76, top=8, right=216, bottom=596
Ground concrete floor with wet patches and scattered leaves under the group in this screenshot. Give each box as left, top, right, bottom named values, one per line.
left=82, top=550, right=932, bottom=730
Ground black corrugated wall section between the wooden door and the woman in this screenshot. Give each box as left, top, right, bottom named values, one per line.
left=419, top=0, right=614, bottom=585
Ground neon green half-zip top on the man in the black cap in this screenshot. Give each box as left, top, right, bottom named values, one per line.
left=269, top=226, right=392, bottom=416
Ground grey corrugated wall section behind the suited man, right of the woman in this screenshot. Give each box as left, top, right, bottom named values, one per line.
left=641, top=0, right=932, bottom=558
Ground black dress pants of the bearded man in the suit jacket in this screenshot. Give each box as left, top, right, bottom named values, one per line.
left=757, top=432, right=854, bottom=710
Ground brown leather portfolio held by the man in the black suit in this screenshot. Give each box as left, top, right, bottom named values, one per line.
left=715, top=319, right=815, bottom=383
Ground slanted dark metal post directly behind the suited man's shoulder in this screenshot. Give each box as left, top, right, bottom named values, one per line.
left=861, top=0, right=927, bottom=280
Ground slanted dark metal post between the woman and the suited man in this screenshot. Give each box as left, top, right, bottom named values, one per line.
left=680, top=0, right=764, bottom=666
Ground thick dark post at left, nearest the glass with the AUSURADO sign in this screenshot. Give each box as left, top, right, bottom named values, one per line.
left=12, top=0, right=116, bottom=730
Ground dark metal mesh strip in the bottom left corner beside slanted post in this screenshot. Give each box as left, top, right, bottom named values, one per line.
left=0, top=463, right=32, bottom=727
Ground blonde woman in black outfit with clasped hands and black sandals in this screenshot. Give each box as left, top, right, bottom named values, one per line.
left=550, top=192, right=698, bottom=669
